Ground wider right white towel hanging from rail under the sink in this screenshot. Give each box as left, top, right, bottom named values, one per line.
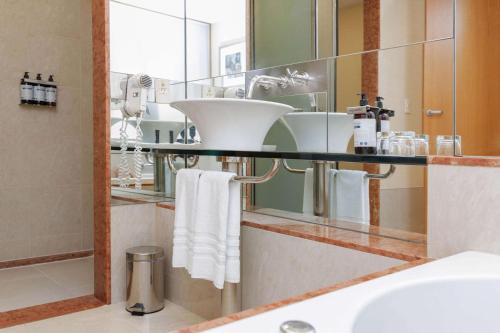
left=173, top=171, right=241, bottom=289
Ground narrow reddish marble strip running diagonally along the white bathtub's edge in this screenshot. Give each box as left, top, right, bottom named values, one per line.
left=172, top=259, right=432, bottom=333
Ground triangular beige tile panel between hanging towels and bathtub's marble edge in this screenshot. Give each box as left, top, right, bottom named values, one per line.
left=242, top=227, right=404, bottom=309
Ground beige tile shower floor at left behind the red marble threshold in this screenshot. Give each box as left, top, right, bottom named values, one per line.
left=0, top=257, right=94, bottom=312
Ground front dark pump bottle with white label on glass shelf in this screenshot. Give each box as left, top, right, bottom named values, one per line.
left=347, top=93, right=377, bottom=155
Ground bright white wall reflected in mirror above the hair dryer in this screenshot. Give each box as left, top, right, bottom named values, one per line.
left=110, top=0, right=210, bottom=81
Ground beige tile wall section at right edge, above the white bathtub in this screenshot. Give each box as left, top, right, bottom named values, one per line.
left=428, top=165, right=500, bottom=258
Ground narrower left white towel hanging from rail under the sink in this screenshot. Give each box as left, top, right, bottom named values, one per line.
left=172, top=169, right=202, bottom=267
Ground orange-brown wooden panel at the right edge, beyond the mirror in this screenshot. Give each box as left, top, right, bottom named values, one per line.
left=457, top=0, right=500, bottom=156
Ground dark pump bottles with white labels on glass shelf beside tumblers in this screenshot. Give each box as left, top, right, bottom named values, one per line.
left=347, top=93, right=394, bottom=155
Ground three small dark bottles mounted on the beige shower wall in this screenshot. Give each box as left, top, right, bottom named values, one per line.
left=20, top=72, right=57, bottom=107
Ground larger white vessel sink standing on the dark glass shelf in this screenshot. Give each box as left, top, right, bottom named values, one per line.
left=170, top=98, right=293, bottom=151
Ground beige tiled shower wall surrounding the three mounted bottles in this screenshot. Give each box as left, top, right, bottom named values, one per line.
left=0, top=0, right=93, bottom=261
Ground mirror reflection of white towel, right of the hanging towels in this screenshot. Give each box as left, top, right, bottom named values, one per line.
left=330, top=170, right=370, bottom=224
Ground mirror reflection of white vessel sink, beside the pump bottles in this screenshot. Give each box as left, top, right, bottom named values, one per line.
left=283, top=112, right=354, bottom=153
